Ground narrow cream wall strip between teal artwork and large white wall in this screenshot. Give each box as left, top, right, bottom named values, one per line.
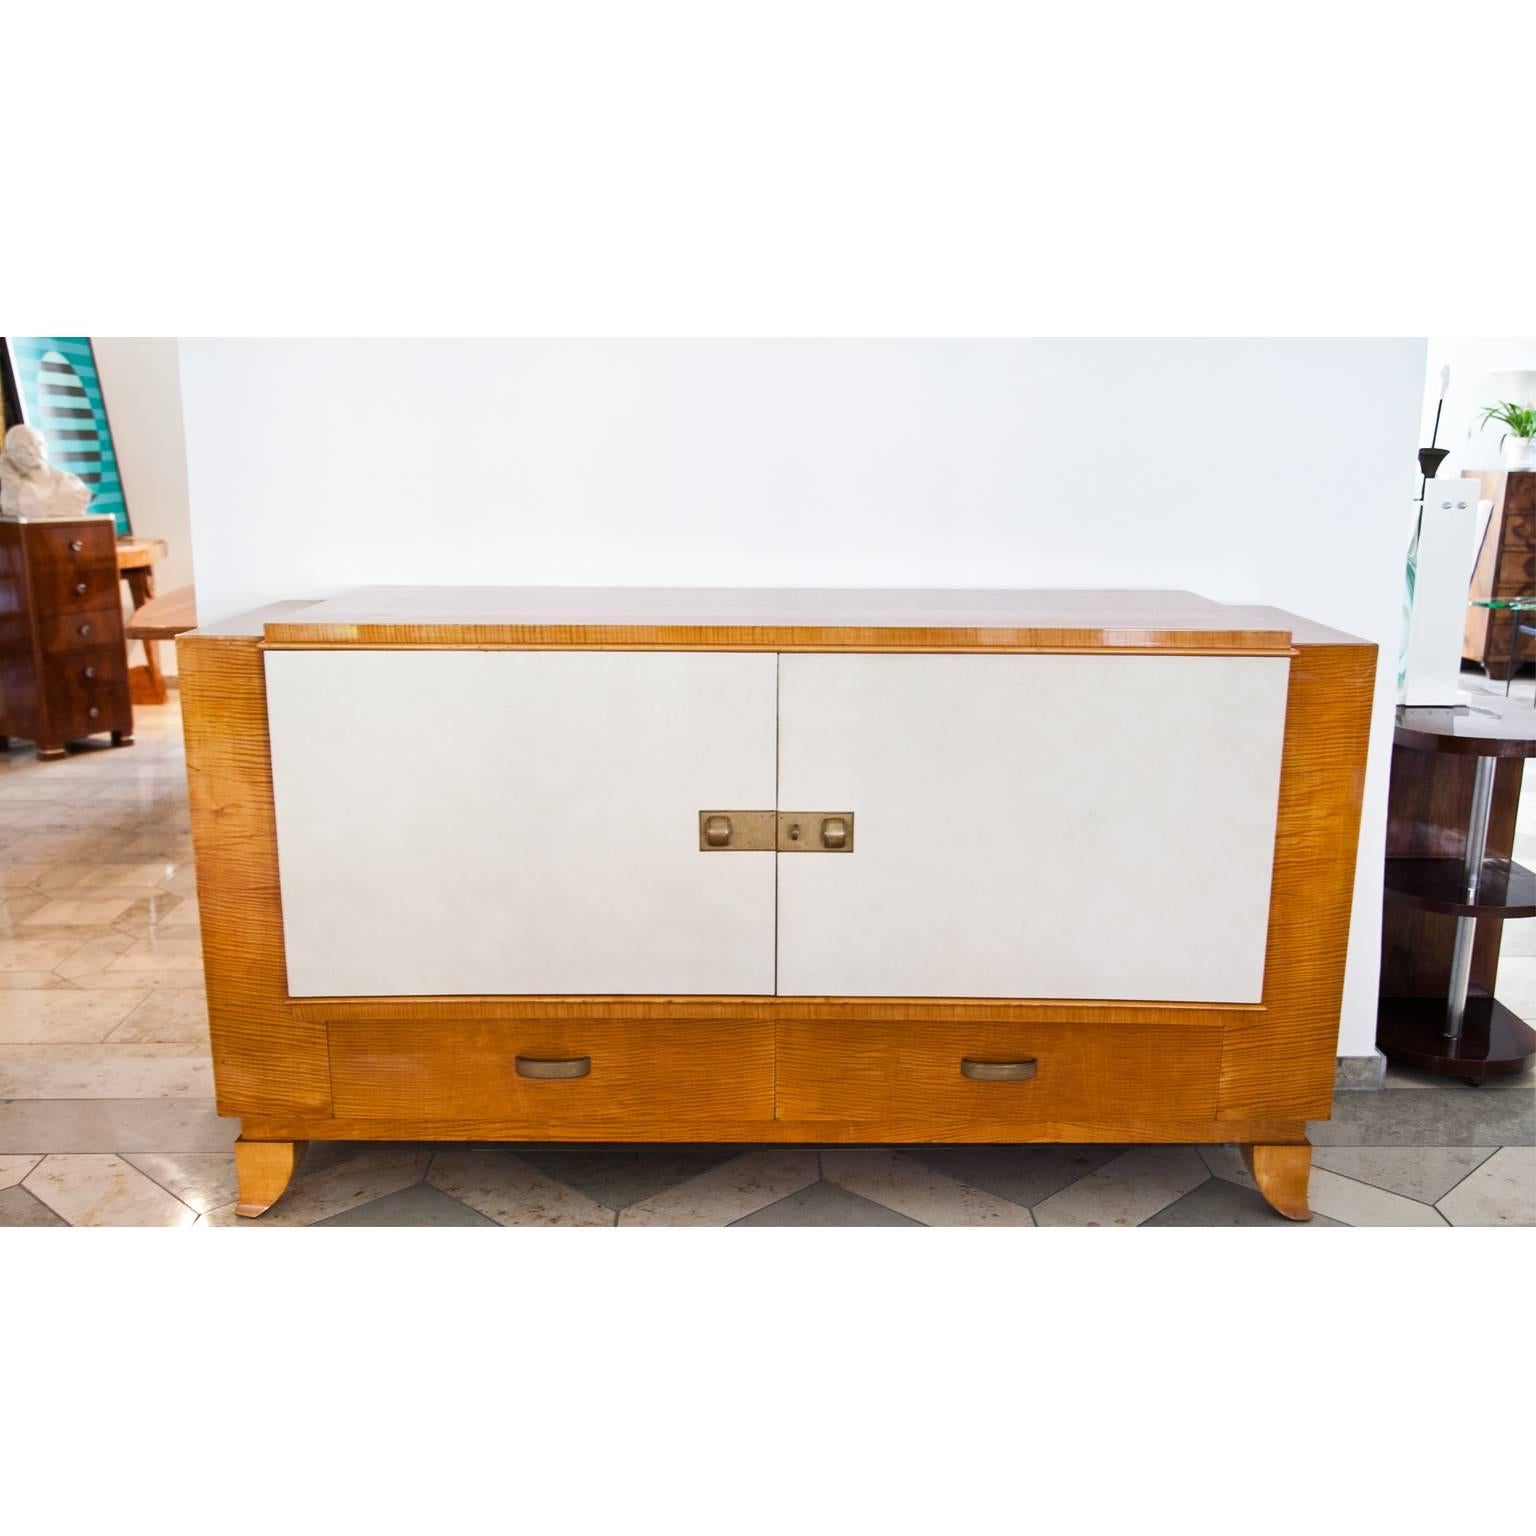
left=91, top=336, right=192, bottom=673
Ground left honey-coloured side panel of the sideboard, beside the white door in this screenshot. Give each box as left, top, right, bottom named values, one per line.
left=177, top=634, right=330, bottom=1115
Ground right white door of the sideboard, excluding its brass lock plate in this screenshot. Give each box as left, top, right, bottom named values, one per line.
left=779, top=654, right=1290, bottom=1003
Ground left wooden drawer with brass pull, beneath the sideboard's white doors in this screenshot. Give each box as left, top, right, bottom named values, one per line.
left=329, top=1018, right=774, bottom=1140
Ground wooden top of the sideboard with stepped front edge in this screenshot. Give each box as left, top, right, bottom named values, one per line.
left=210, top=587, right=1362, bottom=656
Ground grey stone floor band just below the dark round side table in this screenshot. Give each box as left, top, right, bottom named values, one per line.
left=1309, top=1074, right=1536, bottom=1147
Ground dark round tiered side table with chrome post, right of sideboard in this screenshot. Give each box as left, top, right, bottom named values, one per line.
left=1376, top=690, right=1536, bottom=1083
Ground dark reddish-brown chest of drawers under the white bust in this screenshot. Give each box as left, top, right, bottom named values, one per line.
left=0, top=518, right=134, bottom=757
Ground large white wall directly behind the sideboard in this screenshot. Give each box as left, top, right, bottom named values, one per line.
left=181, top=339, right=1425, bottom=1054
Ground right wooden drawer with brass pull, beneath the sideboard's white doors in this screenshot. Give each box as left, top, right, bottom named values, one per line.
left=777, top=1020, right=1221, bottom=1141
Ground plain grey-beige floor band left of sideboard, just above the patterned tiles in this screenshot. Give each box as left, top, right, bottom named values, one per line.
left=0, top=1098, right=238, bottom=1152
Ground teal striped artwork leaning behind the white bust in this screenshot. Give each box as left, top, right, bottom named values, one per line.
left=5, top=336, right=132, bottom=538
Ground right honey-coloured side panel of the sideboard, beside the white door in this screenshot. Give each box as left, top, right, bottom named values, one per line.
left=1218, top=644, right=1376, bottom=1120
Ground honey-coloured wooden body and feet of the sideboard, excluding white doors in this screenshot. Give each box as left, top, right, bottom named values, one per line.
left=178, top=594, right=1375, bottom=1213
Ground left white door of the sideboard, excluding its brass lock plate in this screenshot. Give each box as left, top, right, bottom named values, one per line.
left=266, top=651, right=777, bottom=997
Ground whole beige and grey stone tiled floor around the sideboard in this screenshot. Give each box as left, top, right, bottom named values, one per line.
left=0, top=691, right=1536, bottom=1230
